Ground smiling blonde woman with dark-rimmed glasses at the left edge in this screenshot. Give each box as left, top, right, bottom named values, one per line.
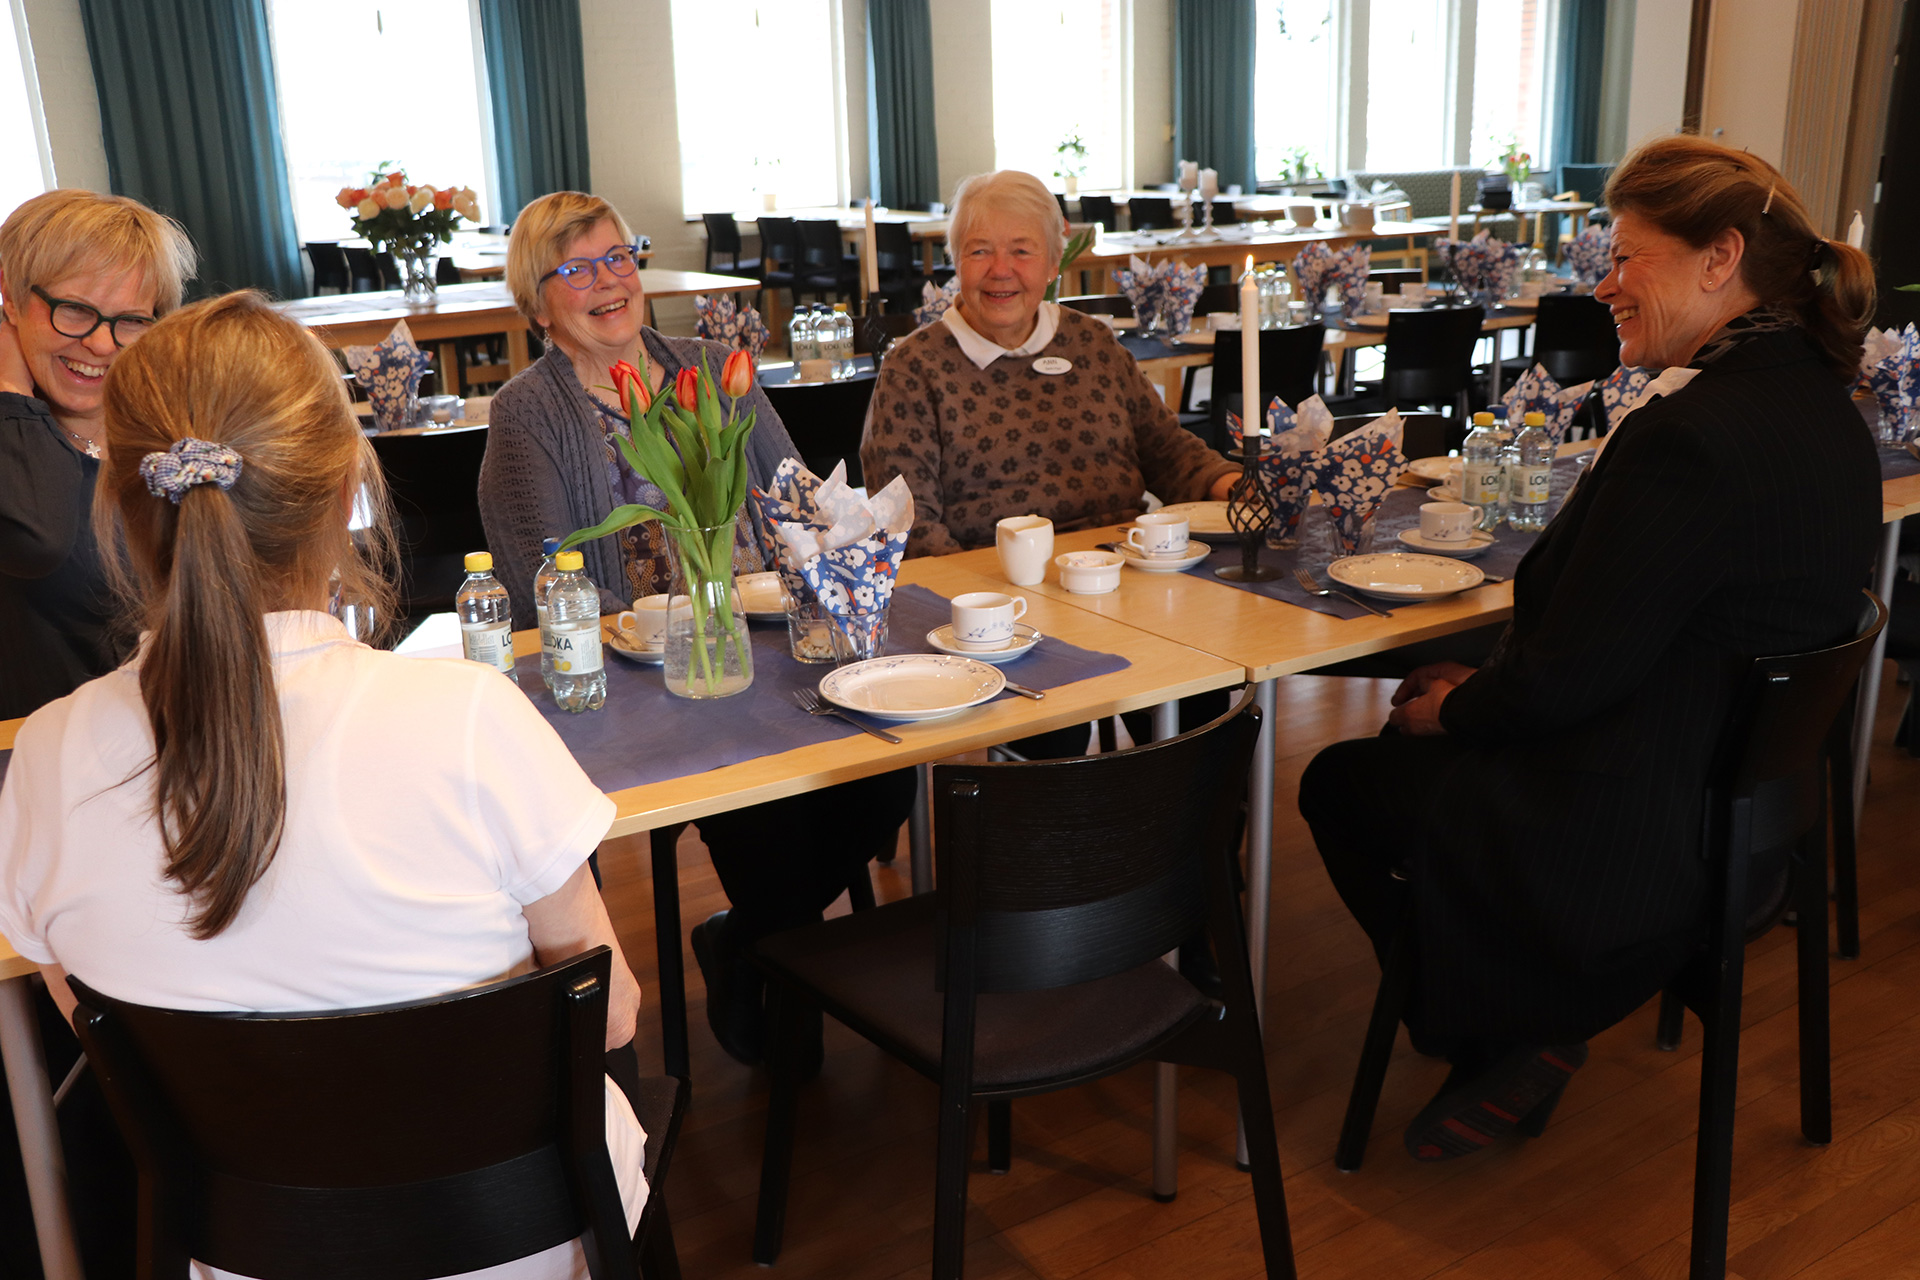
left=0, top=190, right=194, bottom=720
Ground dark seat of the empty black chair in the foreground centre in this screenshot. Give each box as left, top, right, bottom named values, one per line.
left=760, top=896, right=1210, bottom=1090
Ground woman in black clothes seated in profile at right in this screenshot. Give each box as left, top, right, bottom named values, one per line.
left=1300, top=136, right=1880, bottom=1159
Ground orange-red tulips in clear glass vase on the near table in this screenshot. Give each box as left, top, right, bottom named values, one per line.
left=561, top=351, right=753, bottom=699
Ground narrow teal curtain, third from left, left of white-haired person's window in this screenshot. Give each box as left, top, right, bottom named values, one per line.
left=866, top=0, right=941, bottom=209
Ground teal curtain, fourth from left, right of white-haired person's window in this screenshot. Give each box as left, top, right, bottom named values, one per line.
left=1173, top=0, right=1254, bottom=192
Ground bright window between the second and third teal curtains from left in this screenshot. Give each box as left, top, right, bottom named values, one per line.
left=672, top=0, right=847, bottom=215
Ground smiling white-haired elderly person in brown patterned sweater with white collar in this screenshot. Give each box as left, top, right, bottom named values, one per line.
left=860, top=169, right=1238, bottom=555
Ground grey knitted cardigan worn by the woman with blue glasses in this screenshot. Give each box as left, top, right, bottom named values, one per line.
left=480, top=328, right=801, bottom=628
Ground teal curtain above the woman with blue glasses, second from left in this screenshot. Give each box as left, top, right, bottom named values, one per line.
left=480, top=0, right=587, bottom=223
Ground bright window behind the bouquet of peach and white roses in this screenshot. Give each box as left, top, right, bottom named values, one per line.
left=271, top=0, right=505, bottom=240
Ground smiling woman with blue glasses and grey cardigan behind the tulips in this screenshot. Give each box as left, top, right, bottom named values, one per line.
left=480, top=192, right=914, bottom=1065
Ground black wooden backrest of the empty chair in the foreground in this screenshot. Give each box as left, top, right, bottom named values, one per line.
left=933, top=693, right=1260, bottom=992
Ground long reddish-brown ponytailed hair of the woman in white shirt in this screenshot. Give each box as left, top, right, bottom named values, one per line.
left=94, top=294, right=392, bottom=938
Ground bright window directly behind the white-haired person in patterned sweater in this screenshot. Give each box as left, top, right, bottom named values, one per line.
left=993, top=0, right=1131, bottom=190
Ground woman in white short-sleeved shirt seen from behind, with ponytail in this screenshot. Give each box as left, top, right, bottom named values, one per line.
left=0, top=294, right=647, bottom=1278
